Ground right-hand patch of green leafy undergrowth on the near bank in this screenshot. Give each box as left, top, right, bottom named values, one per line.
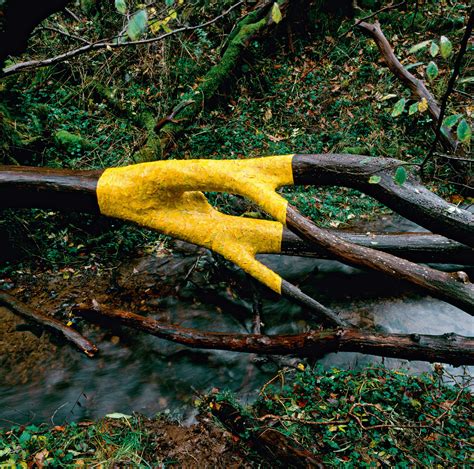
left=212, top=365, right=474, bottom=467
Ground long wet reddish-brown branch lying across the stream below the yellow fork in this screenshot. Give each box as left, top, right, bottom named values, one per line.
left=73, top=302, right=474, bottom=365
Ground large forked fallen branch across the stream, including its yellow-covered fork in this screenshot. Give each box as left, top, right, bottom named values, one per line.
left=0, top=155, right=474, bottom=314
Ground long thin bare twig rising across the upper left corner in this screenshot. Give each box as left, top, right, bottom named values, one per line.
left=3, top=0, right=244, bottom=76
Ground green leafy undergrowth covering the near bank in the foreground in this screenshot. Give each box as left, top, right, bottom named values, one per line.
left=0, top=365, right=474, bottom=468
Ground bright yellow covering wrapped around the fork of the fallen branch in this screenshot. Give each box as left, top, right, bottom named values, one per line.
left=97, top=155, right=293, bottom=293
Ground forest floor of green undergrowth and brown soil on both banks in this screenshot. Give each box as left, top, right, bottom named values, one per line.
left=0, top=2, right=474, bottom=468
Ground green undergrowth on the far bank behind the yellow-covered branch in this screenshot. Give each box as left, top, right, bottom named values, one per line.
left=0, top=1, right=472, bottom=268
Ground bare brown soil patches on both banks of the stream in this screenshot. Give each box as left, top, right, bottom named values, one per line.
left=0, top=246, right=266, bottom=468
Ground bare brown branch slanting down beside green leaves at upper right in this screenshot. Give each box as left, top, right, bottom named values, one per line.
left=358, top=21, right=458, bottom=151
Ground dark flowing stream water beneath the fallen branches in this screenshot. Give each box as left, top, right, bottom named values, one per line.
left=0, top=218, right=474, bottom=426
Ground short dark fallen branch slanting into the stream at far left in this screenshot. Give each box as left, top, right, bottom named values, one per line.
left=0, top=291, right=97, bottom=357
